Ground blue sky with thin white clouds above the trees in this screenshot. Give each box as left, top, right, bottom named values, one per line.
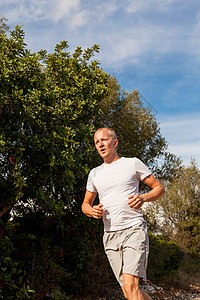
left=0, top=0, right=200, bottom=166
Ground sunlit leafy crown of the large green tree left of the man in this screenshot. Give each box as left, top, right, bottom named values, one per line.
left=0, top=26, right=107, bottom=218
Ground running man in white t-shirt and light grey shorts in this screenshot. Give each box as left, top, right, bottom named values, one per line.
left=82, top=128, right=164, bottom=300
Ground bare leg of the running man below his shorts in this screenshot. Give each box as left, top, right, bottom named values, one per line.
left=122, top=273, right=152, bottom=300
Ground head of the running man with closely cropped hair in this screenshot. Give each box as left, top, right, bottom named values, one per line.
left=94, top=129, right=118, bottom=159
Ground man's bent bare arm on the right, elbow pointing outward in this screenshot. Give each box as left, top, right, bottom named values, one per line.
left=128, top=175, right=165, bottom=209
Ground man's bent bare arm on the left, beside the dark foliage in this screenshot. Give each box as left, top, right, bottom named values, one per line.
left=81, top=190, right=103, bottom=219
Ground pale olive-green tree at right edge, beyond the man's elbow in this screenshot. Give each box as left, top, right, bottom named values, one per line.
left=144, top=160, right=200, bottom=253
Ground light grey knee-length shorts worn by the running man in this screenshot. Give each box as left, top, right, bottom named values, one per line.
left=103, top=223, right=149, bottom=286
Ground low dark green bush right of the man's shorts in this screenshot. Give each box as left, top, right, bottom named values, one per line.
left=147, top=233, right=200, bottom=289
